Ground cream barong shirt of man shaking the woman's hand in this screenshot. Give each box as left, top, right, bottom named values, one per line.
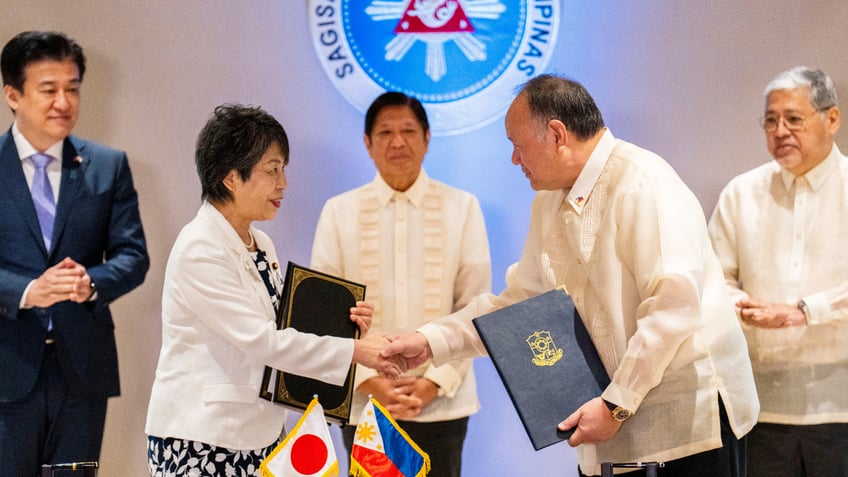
left=419, top=131, right=758, bottom=474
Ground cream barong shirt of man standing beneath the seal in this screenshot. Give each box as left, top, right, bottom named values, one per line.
left=311, top=169, right=491, bottom=423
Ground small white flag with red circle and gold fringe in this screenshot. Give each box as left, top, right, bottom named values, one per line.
left=259, top=397, right=339, bottom=477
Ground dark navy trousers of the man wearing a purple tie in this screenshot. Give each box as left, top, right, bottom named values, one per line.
left=0, top=344, right=106, bottom=477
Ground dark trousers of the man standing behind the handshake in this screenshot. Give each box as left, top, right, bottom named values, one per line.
left=342, top=417, right=468, bottom=477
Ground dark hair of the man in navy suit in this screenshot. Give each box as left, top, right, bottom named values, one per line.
left=0, top=31, right=85, bottom=91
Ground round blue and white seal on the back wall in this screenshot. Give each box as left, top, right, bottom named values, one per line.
left=307, top=0, right=560, bottom=136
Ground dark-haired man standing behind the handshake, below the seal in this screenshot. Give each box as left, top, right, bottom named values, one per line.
left=311, top=92, right=491, bottom=477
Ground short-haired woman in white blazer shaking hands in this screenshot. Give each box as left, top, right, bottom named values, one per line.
left=145, top=105, right=400, bottom=476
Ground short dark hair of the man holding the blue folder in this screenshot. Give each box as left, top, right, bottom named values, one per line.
left=519, top=74, right=604, bottom=141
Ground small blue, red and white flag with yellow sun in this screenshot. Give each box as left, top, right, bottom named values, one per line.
left=350, top=398, right=430, bottom=477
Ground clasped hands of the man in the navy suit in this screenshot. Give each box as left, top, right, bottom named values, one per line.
left=25, top=257, right=92, bottom=308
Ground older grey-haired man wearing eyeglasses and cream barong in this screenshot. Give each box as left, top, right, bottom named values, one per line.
left=709, top=67, right=848, bottom=477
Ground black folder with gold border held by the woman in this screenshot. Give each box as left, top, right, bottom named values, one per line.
left=259, top=262, right=365, bottom=424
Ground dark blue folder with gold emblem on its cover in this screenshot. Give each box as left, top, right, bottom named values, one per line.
left=472, top=288, right=610, bottom=450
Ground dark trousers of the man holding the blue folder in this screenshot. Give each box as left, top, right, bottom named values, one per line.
left=580, top=400, right=744, bottom=477
